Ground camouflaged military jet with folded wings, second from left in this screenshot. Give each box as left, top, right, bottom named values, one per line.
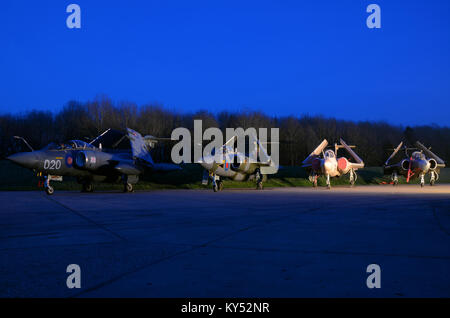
left=197, top=135, right=278, bottom=192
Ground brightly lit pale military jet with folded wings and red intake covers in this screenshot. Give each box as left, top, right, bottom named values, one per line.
left=302, top=138, right=364, bottom=189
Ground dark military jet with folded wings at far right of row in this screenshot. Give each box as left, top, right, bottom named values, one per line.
left=383, top=141, right=445, bottom=187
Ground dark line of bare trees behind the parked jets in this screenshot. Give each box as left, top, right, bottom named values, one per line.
left=0, top=97, right=450, bottom=166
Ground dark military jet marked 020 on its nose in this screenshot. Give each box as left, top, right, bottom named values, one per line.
left=7, top=128, right=180, bottom=195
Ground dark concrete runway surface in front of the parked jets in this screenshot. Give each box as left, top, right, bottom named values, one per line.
left=0, top=184, right=450, bottom=297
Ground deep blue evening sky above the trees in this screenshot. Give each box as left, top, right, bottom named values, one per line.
left=0, top=0, right=450, bottom=126
